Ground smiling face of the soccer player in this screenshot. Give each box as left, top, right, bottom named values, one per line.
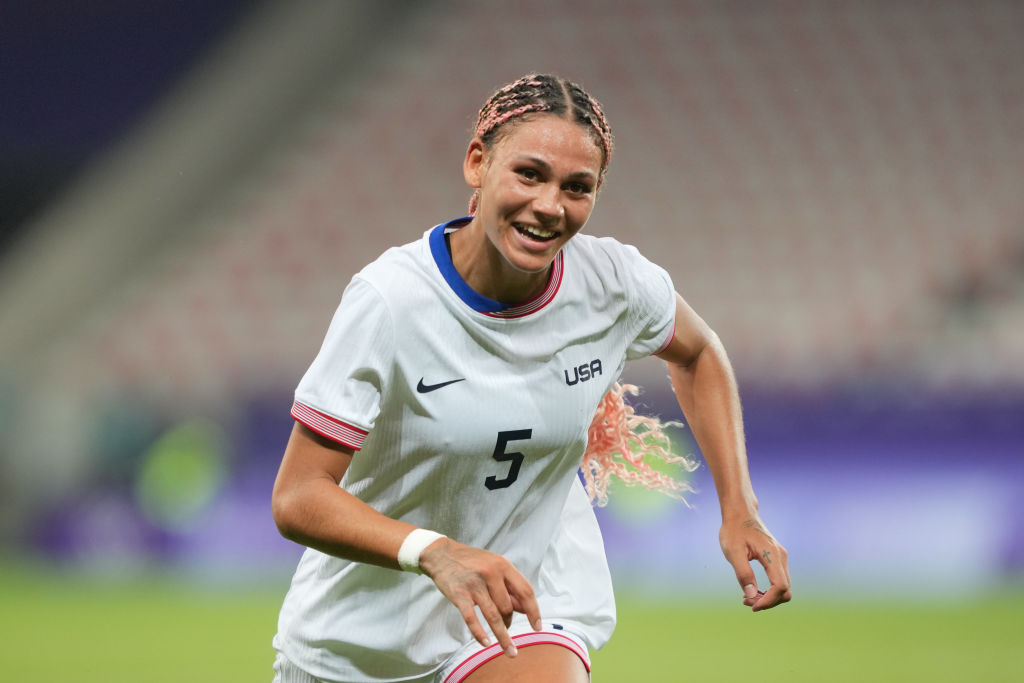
left=457, top=114, right=603, bottom=294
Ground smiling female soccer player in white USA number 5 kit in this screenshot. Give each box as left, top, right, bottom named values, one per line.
left=272, top=75, right=791, bottom=683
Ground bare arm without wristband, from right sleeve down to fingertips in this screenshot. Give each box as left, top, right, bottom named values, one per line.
left=658, top=294, right=793, bottom=611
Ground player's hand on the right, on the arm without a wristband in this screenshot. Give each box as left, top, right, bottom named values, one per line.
left=719, top=516, right=793, bottom=611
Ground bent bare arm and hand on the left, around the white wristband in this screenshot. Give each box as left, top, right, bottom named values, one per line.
left=271, top=423, right=541, bottom=655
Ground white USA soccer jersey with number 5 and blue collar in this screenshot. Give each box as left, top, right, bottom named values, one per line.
left=274, top=218, right=675, bottom=681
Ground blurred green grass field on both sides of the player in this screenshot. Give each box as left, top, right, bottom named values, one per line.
left=0, top=568, right=1024, bottom=683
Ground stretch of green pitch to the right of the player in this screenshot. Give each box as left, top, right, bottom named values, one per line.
left=593, top=593, right=1024, bottom=683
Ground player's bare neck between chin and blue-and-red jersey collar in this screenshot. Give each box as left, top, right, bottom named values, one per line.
left=449, top=218, right=551, bottom=304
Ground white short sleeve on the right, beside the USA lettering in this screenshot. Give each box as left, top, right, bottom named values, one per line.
left=624, top=246, right=676, bottom=360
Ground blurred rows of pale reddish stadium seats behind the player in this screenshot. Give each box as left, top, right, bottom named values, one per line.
left=12, top=0, right=1024, bottom=400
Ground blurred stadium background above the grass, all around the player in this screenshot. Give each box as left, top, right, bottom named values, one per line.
left=0, top=0, right=1024, bottom=679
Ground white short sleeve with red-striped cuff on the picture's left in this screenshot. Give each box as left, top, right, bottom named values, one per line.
left=292, top=275, right=394, bottom=451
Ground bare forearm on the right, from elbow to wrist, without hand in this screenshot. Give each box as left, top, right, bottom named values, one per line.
left=667, top=333, right=758, bottom=521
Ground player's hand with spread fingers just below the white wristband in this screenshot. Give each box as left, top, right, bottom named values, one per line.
left=420, top=538, right=541, bottom=656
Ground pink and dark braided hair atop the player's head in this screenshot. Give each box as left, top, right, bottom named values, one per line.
left=469, top=74, right=613, bottom=215
